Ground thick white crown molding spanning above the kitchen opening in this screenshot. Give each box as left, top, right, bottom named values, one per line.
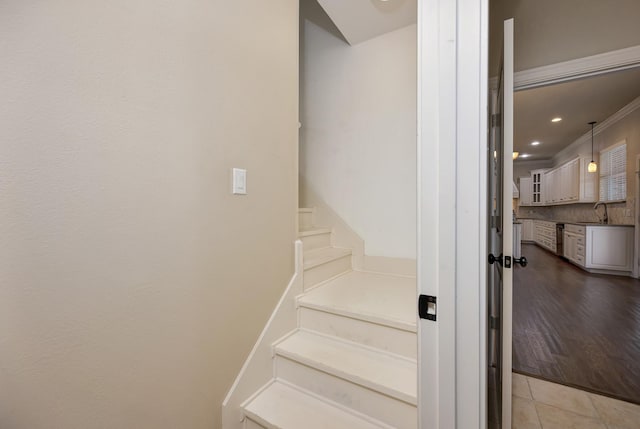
left=489, top=45, right=640, bottom=91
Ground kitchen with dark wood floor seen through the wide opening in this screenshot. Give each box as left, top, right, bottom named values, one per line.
left=513, top=69, right=640, bottom=404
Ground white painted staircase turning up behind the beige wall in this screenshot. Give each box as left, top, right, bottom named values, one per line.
left=242, top=209, right=417, bottom=429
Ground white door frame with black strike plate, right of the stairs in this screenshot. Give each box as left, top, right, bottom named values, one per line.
left=417, top=0, right=489, bottom=429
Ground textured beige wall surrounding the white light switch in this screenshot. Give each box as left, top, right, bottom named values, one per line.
left=0, top=0, right=298, bottom=429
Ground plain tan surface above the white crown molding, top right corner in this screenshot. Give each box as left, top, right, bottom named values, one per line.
left=489, top=0, right=640, bottom=76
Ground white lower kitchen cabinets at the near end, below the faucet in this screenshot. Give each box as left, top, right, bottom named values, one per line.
left=564, top=224, right=634, bottom=274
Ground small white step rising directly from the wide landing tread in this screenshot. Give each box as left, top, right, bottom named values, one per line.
left=303, top=247, right=351, bottom=289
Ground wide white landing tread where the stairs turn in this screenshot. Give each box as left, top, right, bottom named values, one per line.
left=298, top=271, right=416, bottom=332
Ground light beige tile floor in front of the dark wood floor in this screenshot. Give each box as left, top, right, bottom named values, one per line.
left=512, top=373, right=640, bottom=429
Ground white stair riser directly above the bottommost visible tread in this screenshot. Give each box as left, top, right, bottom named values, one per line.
left=275, top=356, right=418, bottom=429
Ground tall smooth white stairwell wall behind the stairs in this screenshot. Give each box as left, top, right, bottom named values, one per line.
left=300, top=22, right=416, bottom=259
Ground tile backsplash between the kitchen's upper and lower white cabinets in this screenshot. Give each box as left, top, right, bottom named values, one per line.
left=515, top=198, right=635, bottom=225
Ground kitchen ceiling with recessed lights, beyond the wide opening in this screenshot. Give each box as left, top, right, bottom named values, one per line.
left=513, top=68, right=640, bottom=161
